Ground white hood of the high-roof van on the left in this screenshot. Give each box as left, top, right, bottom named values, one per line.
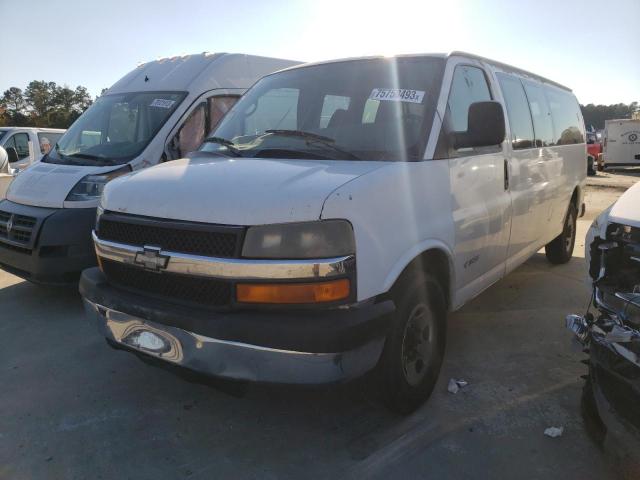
left=7, top=162, right=122, bottom=208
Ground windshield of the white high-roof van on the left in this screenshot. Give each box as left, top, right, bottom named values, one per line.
left=43, top=92, right=186, bottom=166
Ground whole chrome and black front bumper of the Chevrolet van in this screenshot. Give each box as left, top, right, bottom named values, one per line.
left=80, top=268, right=395, bottom=385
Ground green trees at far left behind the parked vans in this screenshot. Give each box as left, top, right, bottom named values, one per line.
left=0, top=80, right=93, bottom=128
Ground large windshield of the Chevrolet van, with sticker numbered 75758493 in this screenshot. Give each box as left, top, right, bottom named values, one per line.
left=205, top=56, right=444, bottom=161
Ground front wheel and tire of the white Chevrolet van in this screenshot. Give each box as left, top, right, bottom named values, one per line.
left=378, top=275, right=447, bottom=415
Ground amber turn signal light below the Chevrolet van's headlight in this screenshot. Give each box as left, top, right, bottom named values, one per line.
left=236, top=278, right=350, bottom=303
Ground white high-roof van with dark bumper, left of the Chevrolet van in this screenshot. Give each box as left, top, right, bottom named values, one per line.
left=0, top=53, right=296, bottom=284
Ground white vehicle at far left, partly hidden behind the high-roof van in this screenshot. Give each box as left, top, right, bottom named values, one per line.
left=0, top=127, right=65, bottom=170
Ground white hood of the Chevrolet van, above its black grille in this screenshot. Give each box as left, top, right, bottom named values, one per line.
left=102, top=157, right=385, bottom=225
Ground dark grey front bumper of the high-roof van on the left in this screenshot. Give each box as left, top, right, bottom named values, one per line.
left=0, top=200, right=96, bottom=285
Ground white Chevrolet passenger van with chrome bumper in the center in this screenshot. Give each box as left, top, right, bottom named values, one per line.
left=80, top=53, right=586, bottom=412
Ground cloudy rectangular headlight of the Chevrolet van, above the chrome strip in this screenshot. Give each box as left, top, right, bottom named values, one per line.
left=242, top=220, right=356, bottom=259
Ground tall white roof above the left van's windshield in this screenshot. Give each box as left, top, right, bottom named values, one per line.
left=106, top=52, right=300, bottom=94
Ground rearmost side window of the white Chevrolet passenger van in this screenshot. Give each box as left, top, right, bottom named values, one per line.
left=544, top=85, right=584, bottom=145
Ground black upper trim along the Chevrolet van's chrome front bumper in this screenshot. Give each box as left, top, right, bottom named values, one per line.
left=80, top=268, right=395, bottom=353
